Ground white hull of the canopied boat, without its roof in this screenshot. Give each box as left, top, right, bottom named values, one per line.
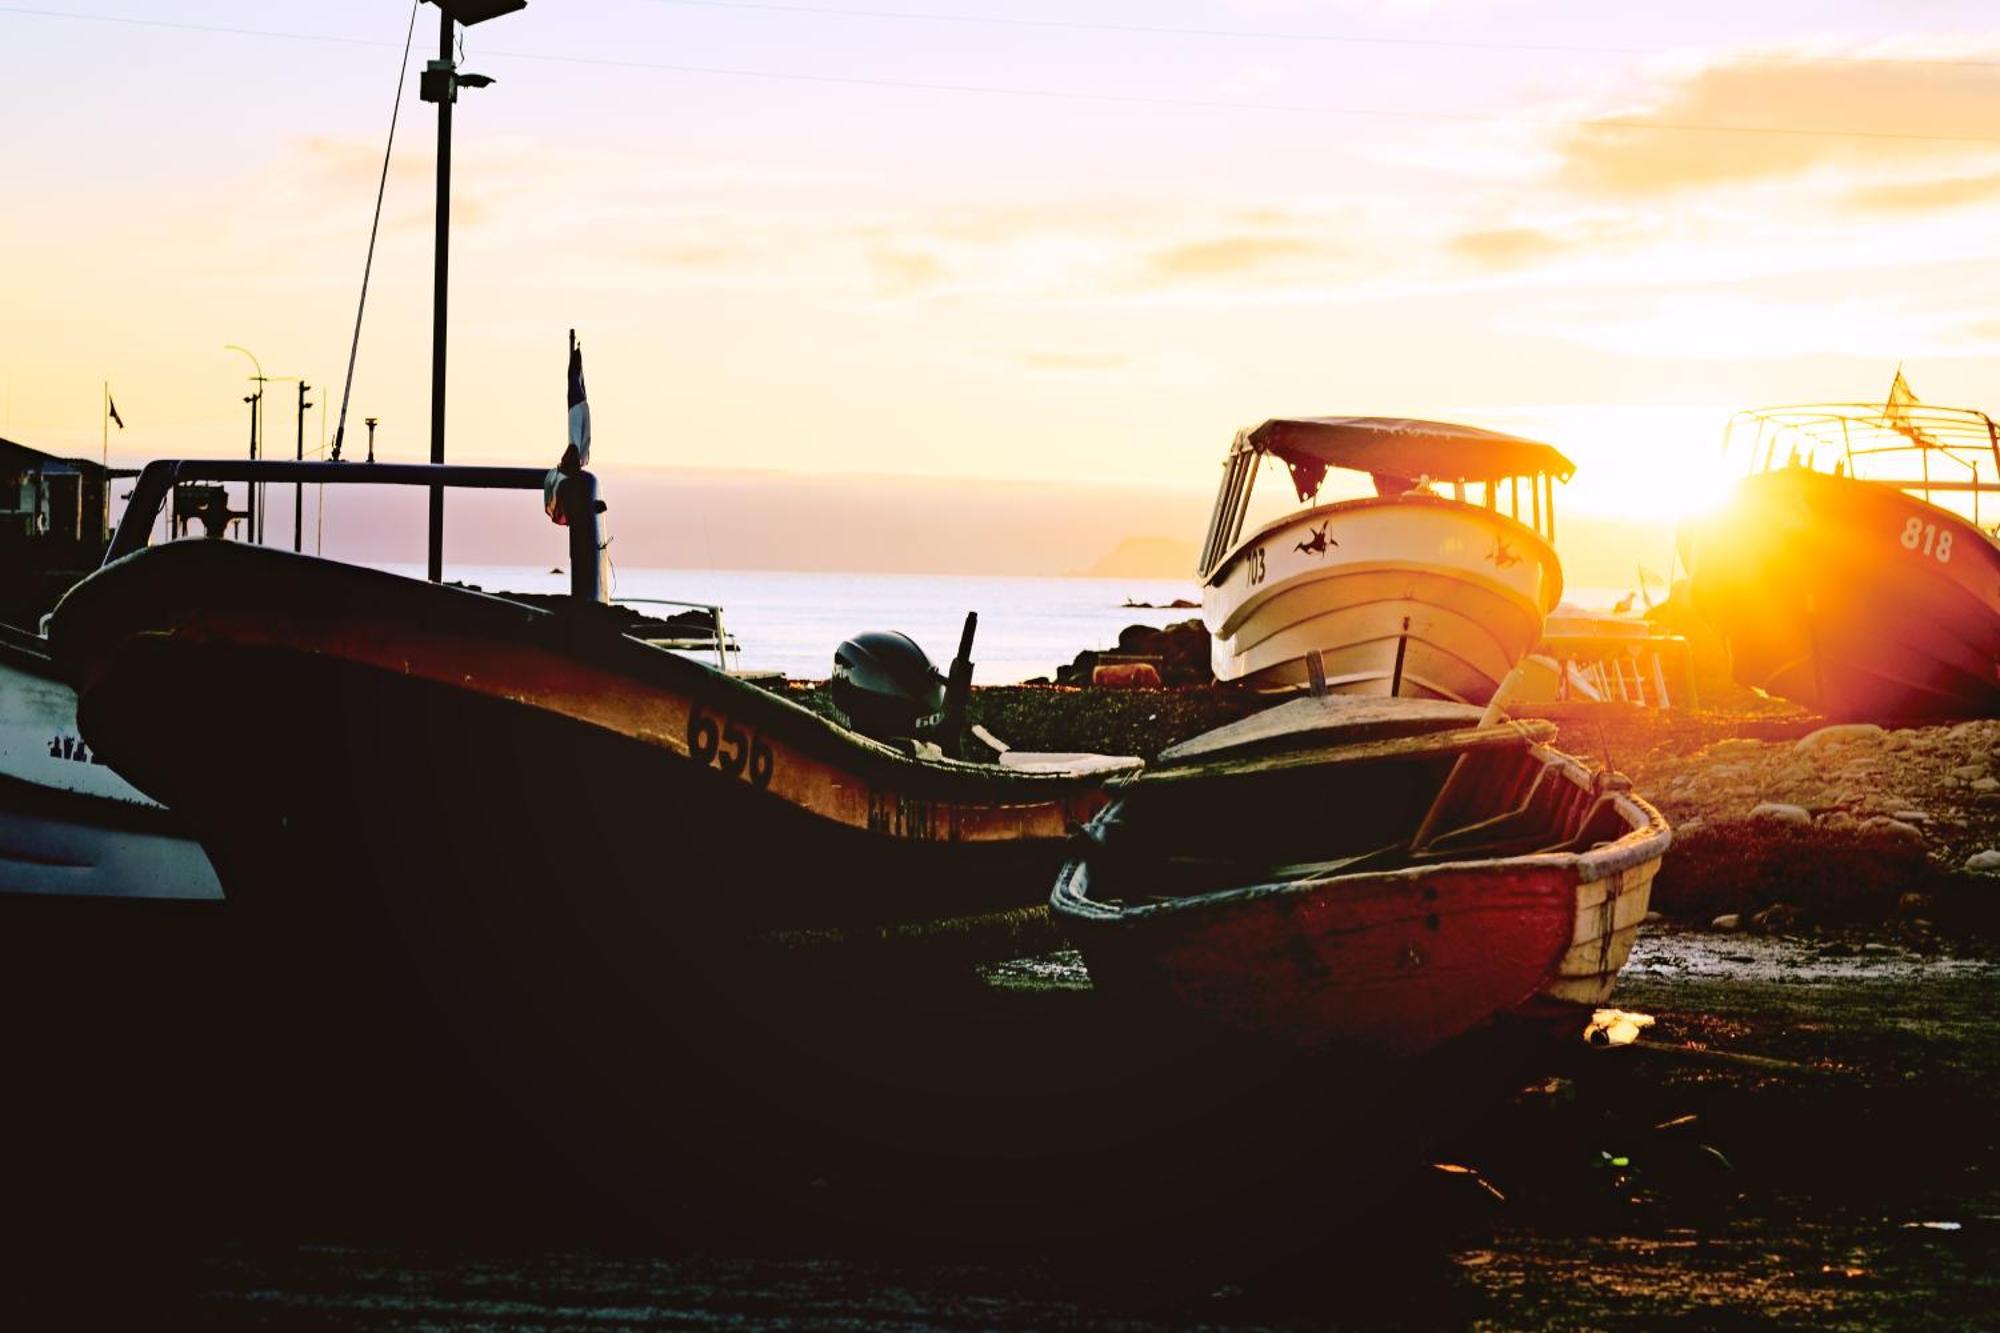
left=1202, top=494, right=1562, bottom=705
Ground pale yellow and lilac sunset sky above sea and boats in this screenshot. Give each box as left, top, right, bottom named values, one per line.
left=0, top=0, right=2000, bottom=572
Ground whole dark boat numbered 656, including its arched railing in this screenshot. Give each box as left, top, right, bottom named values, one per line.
left=50, top=464, right=1138, bottom=956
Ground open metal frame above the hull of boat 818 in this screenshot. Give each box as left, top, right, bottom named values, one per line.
left=1724, top=396, right=2000, bottom=528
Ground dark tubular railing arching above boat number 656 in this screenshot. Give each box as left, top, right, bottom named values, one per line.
left=104, top=458, right=608, bottom=602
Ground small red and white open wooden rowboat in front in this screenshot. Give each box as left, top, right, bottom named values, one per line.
left=1052, top=697, right=1668, bottom=1059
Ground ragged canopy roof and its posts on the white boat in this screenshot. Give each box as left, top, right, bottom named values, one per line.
left=1198, top=416, right=1576, bottom=580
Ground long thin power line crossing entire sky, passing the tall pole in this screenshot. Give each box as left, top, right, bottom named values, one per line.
left=0, top=0, right=2000, bottom=144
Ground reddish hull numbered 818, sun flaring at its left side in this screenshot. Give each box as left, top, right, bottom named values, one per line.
left=1688, top=468, right=2000, bottom=721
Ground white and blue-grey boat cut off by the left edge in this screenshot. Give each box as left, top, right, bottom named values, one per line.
left=0, top=624, right=222, bottom=901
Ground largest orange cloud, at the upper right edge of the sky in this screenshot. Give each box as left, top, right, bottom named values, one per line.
left=1558, top=48, right=2000, bottom=196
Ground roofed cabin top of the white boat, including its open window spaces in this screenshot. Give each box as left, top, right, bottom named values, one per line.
left=1198, top=416, right=1574, bottom=578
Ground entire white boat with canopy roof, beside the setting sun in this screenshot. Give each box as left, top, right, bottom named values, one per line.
left=1200, top=416, right=1574, bottom=705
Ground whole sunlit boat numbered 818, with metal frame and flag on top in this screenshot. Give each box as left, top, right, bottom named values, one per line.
left=1682, top=374, right=2000, bottom=721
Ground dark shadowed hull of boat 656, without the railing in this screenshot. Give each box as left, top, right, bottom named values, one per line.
left=52, top=542, right=1144, bottom=1087
